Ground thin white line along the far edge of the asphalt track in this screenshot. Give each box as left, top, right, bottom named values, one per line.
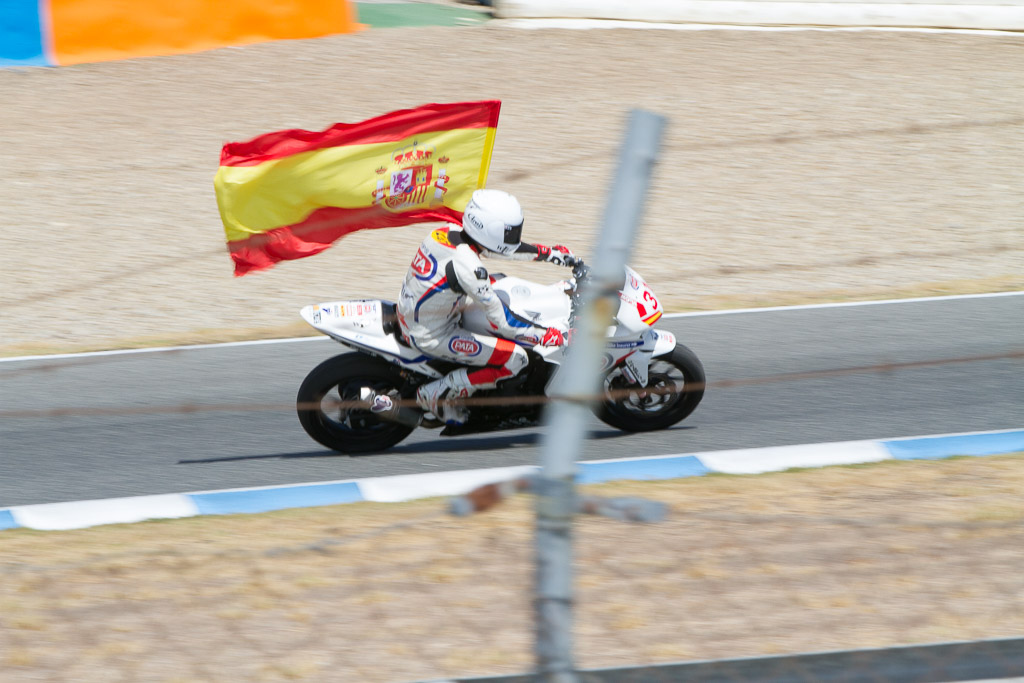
left=0, top=291, right=1024, bottom=362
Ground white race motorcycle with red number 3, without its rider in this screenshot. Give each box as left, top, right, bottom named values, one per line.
left=298, top=261, right=705, bottom=454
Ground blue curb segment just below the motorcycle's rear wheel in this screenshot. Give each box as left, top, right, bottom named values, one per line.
left=188, top=481, right=364, bottom=515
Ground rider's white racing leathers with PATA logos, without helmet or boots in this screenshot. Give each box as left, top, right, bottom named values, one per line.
left=398, top=225, right=551, bottom=395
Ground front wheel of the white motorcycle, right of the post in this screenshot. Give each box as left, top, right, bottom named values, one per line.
left=595, top=344, right=706, bottom=432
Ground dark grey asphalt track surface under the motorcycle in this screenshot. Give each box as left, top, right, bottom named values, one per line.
left=0, top=296, right=1024, bottom=507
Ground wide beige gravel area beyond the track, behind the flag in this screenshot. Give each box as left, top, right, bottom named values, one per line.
left=0, top=22, right=1024, bottom=355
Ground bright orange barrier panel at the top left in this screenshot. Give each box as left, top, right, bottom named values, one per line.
left=49, top=0, right=361, bottom=65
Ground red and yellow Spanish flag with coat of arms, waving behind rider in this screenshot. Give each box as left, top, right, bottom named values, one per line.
left=214, top=100, right=501, bottom=275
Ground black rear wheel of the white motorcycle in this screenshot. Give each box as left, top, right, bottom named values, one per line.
left=296, top=353, right=413, bottom=454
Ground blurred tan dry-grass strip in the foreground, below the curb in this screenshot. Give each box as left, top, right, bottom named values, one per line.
left=0, top=454, right=1024, bottom=683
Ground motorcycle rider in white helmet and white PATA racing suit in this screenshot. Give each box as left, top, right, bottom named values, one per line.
left=397, top=189, right=577, bottom=425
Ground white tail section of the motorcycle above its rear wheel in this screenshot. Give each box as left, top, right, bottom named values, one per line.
left=299, top=299, right=441, bottom=377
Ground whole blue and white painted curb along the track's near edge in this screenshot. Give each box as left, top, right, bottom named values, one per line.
left=0, top=429, right=1024, bottom=530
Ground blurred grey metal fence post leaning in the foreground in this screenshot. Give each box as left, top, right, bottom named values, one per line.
left=535, top=110, right=666, bottom=683
